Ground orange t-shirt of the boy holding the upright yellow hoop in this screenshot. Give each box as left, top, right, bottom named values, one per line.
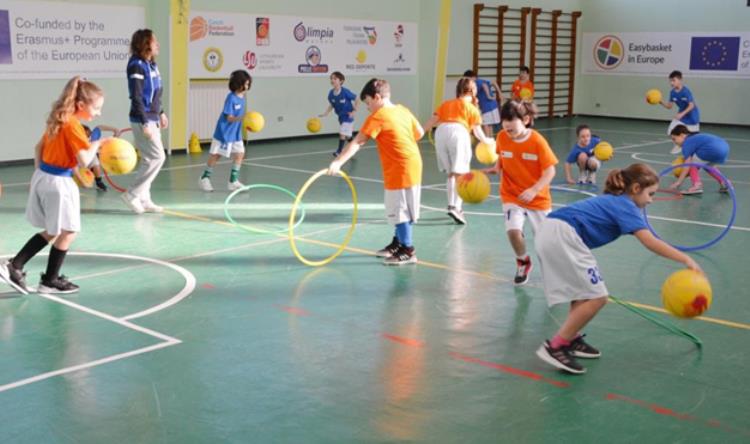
left=359, top=105, right=422, bottom=190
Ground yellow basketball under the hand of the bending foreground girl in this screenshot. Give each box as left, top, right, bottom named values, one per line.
left=661, top=269, right=712, bottom=318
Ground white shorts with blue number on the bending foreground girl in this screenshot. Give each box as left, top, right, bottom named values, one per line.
left=534, top=218, right=609, bottom=305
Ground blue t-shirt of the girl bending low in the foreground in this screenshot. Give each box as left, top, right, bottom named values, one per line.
left=547, top=194, right=648, bottom=248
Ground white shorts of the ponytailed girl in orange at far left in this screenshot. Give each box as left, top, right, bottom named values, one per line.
left=26, top=169, right=81, bottom=236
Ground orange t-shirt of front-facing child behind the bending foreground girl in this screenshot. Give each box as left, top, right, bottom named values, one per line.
left=497, top=130, right=557, bottom=210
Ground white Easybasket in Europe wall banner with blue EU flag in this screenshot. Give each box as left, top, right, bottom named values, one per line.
left=582, top=31, right=750, bottom=78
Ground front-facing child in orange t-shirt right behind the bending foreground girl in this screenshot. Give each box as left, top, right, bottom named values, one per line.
left=486, top=100, right=557, bottom=285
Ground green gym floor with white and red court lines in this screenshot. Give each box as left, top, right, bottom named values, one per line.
left=0, top=118, right=750, bottom=443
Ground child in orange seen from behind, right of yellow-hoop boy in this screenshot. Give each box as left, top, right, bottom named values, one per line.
left=424, top=77, right=499, bottom=225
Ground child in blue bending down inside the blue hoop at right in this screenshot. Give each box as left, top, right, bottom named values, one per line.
left=669, top=125, right=729, bottom=195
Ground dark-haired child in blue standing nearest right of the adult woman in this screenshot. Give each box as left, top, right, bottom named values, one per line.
left=198, top=69, right=253, bottom=192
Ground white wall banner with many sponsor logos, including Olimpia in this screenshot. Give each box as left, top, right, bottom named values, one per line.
left=188, top=11, right=417, bottom=79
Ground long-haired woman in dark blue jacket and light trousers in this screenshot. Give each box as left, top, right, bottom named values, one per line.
left=122, top=29, right=169, bottom=214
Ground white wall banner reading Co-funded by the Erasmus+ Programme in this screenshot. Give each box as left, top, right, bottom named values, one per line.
left=0, top=0, right=145, bottom=79
